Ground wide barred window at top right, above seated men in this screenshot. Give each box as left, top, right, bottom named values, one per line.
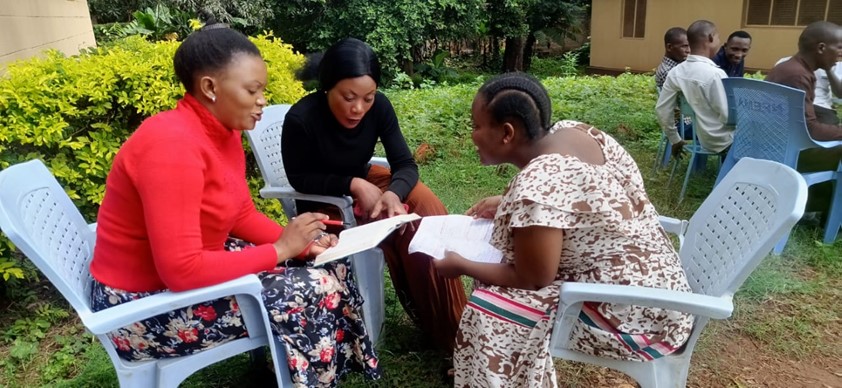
left=745, top=0, right=842, bottom=26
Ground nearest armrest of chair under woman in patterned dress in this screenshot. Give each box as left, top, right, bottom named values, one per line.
left=559, top=282, right=734, bottom=319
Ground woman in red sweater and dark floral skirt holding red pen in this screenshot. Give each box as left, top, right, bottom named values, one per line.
left=91, top=23, right=379, bottom=386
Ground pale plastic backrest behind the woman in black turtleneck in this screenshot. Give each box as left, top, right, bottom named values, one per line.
left=244, top=104, right=291, bottom=187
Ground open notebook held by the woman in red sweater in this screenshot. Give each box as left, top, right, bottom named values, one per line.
left=313, top=213, right=421, bottom=265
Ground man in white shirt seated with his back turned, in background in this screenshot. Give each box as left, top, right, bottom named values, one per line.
left=655, top=20, right=734, bottom=157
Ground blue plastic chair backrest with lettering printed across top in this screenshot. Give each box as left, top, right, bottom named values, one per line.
left=722, top=78, right=815, bottom=168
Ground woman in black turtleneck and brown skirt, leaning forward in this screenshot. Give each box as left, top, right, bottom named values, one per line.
left=281, top=38, right=466, bottom=354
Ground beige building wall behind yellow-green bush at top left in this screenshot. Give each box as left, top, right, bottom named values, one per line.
left=0, top=0, right=96, bottom=68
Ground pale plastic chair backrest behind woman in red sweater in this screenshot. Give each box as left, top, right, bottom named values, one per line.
left=0, top=160, right=96, bottom=315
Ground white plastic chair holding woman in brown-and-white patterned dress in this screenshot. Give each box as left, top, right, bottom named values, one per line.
left=550, top=158, right=807, bottom=388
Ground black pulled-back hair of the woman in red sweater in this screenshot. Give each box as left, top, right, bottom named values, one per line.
left=173, top=19, right=260, bottom=93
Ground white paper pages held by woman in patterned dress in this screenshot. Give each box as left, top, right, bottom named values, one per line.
left=409, top=215, right=503, bottom=263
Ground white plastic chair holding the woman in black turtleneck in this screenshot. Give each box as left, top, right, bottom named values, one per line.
left=245, top=105, right=389, bottom=343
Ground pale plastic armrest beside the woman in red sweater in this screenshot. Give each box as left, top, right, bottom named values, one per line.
left=80, top=274, right=263, bottom=335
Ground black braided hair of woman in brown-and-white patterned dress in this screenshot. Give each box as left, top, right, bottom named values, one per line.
left=477, top=72, right=552, bottom=140
